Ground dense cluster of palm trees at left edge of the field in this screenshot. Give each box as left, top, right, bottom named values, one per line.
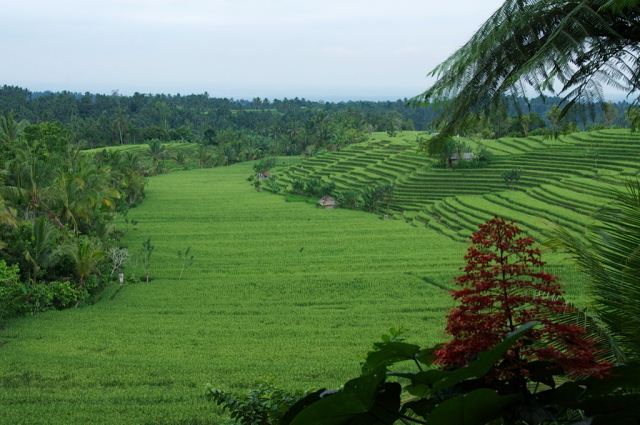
left=0, top=119, right=145, bottom=313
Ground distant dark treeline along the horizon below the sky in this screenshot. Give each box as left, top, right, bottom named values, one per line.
left=0, top=85, right=628, bottom=150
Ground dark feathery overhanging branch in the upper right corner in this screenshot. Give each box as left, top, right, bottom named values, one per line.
left=412, top=0, right=640, bottom=147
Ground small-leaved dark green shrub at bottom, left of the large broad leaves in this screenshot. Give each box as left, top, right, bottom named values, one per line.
left=205, top=380, right=307, bottom=425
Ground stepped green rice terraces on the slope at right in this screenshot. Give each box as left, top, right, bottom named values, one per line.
left=280, top=130, right=640, bottom=241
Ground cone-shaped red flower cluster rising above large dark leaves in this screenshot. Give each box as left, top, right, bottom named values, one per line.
left=436, top=217, right=610, bottom=379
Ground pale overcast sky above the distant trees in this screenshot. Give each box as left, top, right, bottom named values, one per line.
left=0, top=0, right=502, bottom=101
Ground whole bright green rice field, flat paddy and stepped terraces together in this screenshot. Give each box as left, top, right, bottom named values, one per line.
left=0, top=131, right=640, bottom=424
